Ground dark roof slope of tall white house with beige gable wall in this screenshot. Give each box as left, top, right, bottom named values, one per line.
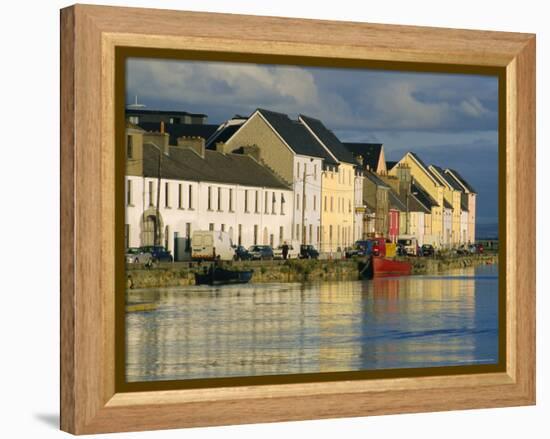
left=257, top=108, right=338, bottom=165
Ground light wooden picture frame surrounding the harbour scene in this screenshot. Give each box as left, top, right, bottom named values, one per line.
left=61, top=5, right=535, bottom=434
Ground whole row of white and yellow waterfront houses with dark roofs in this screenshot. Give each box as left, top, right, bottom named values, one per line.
left=125, top=108, right=476, bottom=260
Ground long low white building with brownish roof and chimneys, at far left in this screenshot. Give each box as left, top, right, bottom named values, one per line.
left=126, top=125, right=293, bottom=260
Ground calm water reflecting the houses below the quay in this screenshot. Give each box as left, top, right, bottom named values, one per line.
left=126, top=265, right=498, bottom=381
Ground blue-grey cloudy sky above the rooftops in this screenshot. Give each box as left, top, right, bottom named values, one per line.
left=126, top=58, right=498, bottom=230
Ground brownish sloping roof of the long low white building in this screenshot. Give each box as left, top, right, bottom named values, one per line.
left=143, top=143, right=290, bottom=190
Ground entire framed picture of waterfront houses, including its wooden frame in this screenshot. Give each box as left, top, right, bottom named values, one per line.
left=61, top=5, right=535, bottom=434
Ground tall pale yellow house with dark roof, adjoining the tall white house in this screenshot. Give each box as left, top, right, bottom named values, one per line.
left=299, top=115, right=361, bottom=253
